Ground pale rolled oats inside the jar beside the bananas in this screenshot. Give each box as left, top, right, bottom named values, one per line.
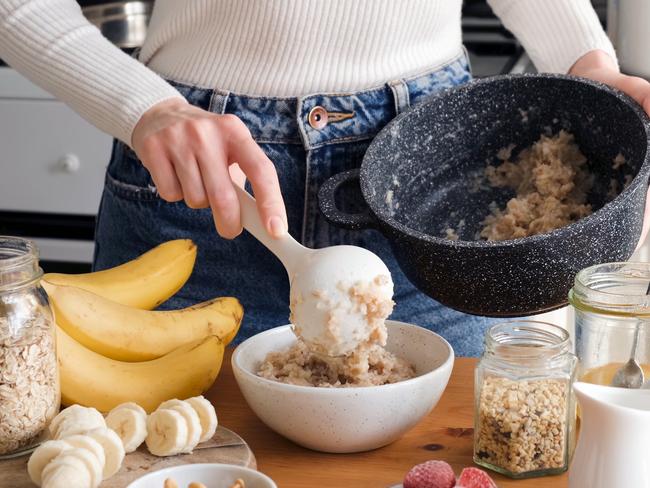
left=0, top=316, right=60, bottom=454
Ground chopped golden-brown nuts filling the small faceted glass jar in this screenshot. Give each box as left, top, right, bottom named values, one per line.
left=475, top=376, right=570, bottom=474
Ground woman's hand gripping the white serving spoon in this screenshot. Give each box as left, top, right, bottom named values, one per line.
left=132, top=99, right=287, bottom=239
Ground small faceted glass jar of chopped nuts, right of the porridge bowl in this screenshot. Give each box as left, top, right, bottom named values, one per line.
left=474, top=320, right=577, bottom=478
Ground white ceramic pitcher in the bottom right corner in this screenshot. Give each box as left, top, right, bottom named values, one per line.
left=569, top=383, right=650, bottom=488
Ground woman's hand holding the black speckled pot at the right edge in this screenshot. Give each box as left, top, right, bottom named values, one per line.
left=569, top=50, right=650, bottom=246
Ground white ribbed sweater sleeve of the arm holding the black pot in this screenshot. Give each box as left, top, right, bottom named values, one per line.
left=488, top=0, right=617, bottom=73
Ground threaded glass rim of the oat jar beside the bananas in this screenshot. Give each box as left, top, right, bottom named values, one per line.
left=0, top=235, right=43, bottom=292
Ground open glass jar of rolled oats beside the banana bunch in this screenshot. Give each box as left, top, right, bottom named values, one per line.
left=0, top=236, right=61, bottom=459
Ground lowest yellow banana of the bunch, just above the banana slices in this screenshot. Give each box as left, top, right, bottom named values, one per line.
left=56, top=327, right=224, bottom=413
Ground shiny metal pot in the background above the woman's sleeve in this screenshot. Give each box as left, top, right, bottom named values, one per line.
left=82, top=1, right=153, bottom=49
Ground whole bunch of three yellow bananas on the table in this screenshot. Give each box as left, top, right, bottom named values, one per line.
left=42, top=240, right=243, bottom=412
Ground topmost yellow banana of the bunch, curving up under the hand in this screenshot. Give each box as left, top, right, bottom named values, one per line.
left=43, top=239, right=196, bottom=310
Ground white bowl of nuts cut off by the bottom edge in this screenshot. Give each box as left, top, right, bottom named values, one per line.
left=126, top=463, right=278, bottom=488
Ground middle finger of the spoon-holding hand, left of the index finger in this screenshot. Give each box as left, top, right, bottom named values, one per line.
left=199, top=140, right=242, bottom=239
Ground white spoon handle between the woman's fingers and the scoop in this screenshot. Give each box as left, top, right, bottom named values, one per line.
left=233, top=184, right=312, bottom=274
